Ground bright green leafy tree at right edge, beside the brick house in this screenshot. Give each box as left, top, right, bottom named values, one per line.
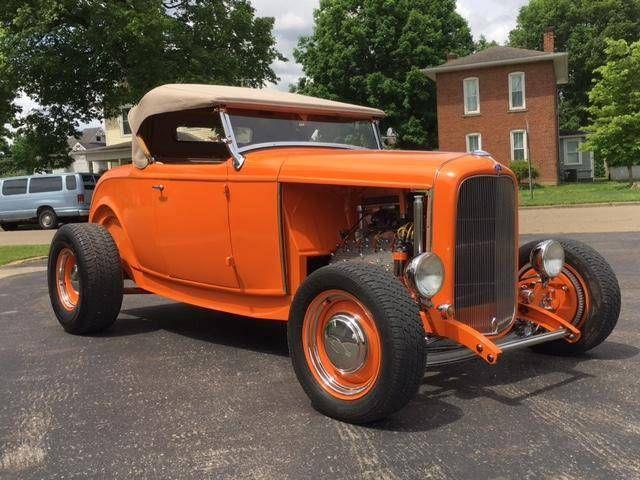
left=584, top=40, right=640, bottom=184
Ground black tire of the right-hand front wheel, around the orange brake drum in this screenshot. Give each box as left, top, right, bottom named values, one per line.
left=519, top=239, right=620, bottom=356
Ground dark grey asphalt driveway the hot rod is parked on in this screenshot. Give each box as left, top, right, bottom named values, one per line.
left=0, top=233, right=640, bottom=479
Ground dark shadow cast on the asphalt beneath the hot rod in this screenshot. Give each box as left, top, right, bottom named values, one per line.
left=109, top=303, right=640, bottom=432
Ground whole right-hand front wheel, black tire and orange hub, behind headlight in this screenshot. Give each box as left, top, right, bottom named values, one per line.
left=519, top=239, right=620, bottom=356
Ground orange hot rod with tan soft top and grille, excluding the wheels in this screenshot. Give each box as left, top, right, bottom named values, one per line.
left=84, top=85, right=592, bottom=364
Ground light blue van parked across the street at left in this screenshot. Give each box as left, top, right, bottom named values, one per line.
left=0, top=173, right=98, bottom=230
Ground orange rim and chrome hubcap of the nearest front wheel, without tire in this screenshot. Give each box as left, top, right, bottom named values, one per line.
left=302, top=290, right=382, bottom=400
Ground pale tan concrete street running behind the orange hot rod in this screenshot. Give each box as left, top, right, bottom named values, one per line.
left=0, top=204, right=640, bottom=246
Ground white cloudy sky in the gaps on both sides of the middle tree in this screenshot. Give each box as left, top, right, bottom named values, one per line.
left=252, top=0, right=528, bottom=90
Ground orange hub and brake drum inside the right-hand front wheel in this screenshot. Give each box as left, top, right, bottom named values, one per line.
left=519, top=264, right=590, bottom=327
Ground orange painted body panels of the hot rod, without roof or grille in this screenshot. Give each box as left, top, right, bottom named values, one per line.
left=90, top=148, right=502, bottom=326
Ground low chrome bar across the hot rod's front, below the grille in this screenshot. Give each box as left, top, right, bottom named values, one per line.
left=425, top=328, right=567, bottom=367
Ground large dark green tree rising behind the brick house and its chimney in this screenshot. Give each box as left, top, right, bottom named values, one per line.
left=509, top=0, right=640, bottom=130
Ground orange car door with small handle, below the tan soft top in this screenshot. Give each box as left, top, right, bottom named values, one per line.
left=144, top=161, right=238, bottom=289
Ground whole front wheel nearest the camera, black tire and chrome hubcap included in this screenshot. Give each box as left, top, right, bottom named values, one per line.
left=288, top=262, right=426, bottom=424
